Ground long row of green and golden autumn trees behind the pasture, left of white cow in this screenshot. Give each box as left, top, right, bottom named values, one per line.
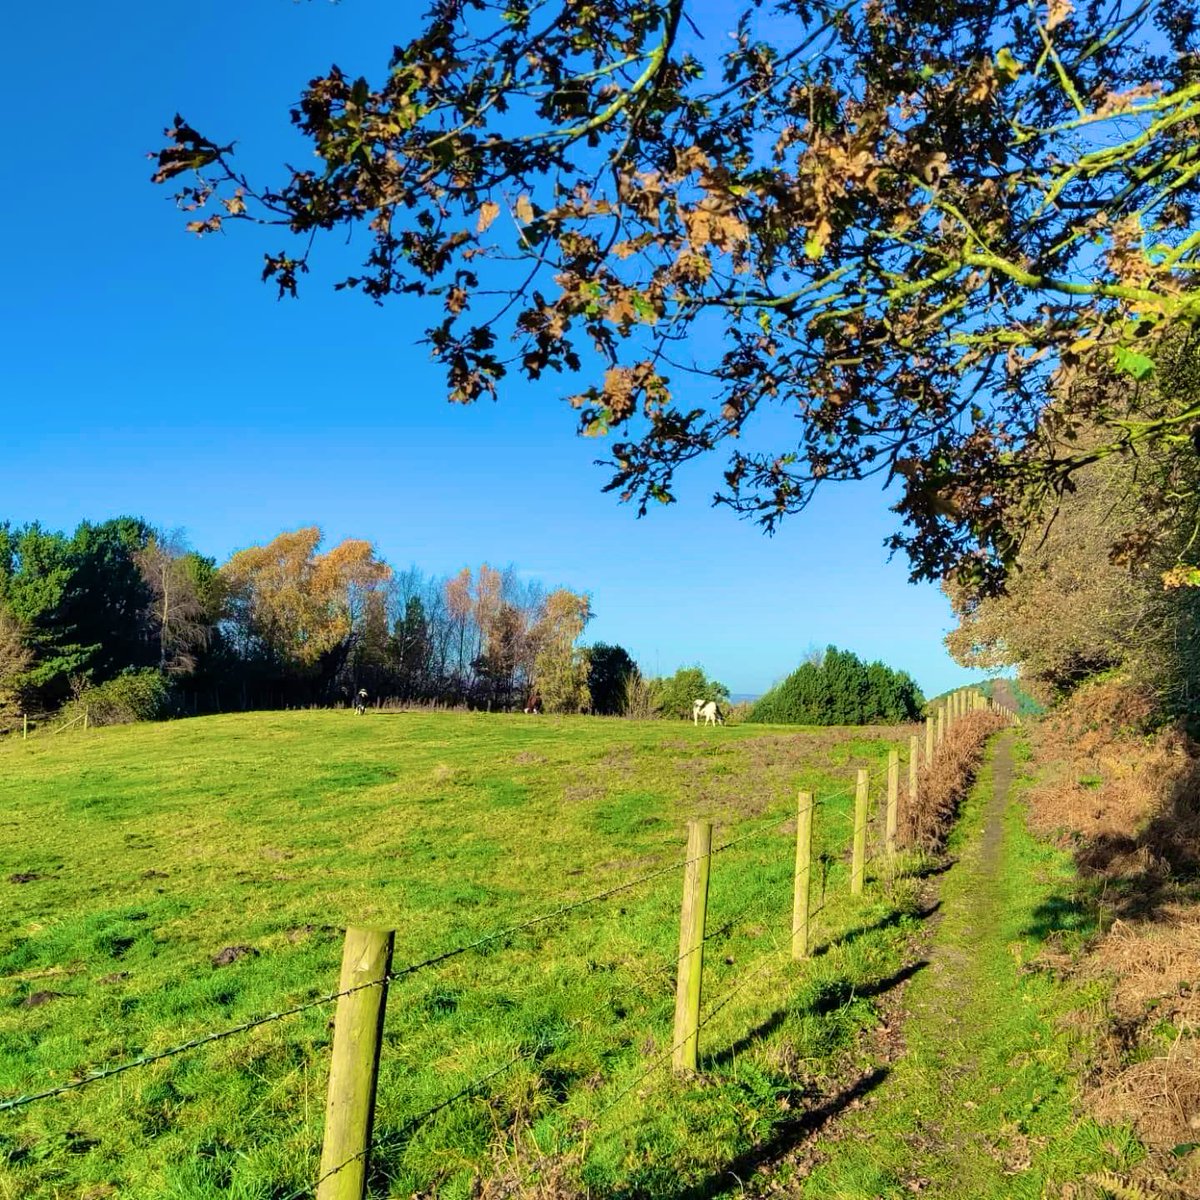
left=0, top=517, right=728, bottom=727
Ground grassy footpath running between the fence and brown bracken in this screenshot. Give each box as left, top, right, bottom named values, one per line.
left=792, top=733, right=1136, bottom=1200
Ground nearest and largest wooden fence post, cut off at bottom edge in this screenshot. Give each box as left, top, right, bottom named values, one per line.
left=317, top=928, right=395, bottom=1200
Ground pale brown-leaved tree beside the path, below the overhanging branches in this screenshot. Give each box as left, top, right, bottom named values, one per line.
left=946, top=354, right=1200, bottom=718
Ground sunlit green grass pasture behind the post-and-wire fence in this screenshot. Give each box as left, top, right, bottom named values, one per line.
left=0, top=712, right=919, bottom=1200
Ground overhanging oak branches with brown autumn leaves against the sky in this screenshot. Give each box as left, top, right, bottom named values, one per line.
left=154, top=0, right=1200, bottom=586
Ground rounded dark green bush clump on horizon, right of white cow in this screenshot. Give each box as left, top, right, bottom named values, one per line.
left=748, top=646, right=925, bottom=725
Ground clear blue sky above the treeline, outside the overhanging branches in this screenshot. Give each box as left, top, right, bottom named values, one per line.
left=0, top=0, right=984, bottom=694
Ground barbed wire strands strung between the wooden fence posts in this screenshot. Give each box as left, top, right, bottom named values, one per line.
left=0, top=710, right=993, bottom=1200
